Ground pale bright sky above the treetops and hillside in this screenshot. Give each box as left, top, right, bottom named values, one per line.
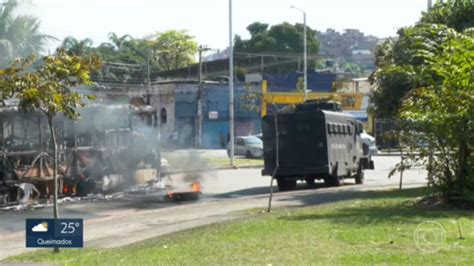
left=19, top=0, right=427, bottom=51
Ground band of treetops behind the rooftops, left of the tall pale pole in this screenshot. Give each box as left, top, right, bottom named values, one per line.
left=62, top=30, right=198, bottom=83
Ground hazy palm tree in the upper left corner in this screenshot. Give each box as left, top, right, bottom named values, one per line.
left=0, top=0, right=54, bottom=67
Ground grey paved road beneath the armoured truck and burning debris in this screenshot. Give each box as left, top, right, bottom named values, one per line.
left=0, top=156, right=426, bottom=259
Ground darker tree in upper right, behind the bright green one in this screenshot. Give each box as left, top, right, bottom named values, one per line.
left=371, top=0, right=474, bottom=118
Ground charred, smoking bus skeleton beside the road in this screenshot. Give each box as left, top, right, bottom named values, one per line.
left=0, top=104, right=161, bottom=205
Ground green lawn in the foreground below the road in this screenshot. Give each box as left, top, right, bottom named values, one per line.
left=8, top=189, right=474, bottom=265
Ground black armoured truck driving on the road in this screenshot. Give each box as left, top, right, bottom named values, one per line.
left=262, top=102, right=373, bottom=191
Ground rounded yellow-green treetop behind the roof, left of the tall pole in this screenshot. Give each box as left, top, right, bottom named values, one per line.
left=147, top=30, right=198, bottom=70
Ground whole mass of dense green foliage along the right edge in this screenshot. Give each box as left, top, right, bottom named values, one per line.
left=372, top=0, right=474, bottom=200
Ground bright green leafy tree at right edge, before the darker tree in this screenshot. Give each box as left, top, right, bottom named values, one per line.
left=401, top=30, right=474, bottom=198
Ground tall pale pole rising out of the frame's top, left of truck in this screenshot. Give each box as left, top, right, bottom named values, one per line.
left=229, top=0, right=234, bottom=166
